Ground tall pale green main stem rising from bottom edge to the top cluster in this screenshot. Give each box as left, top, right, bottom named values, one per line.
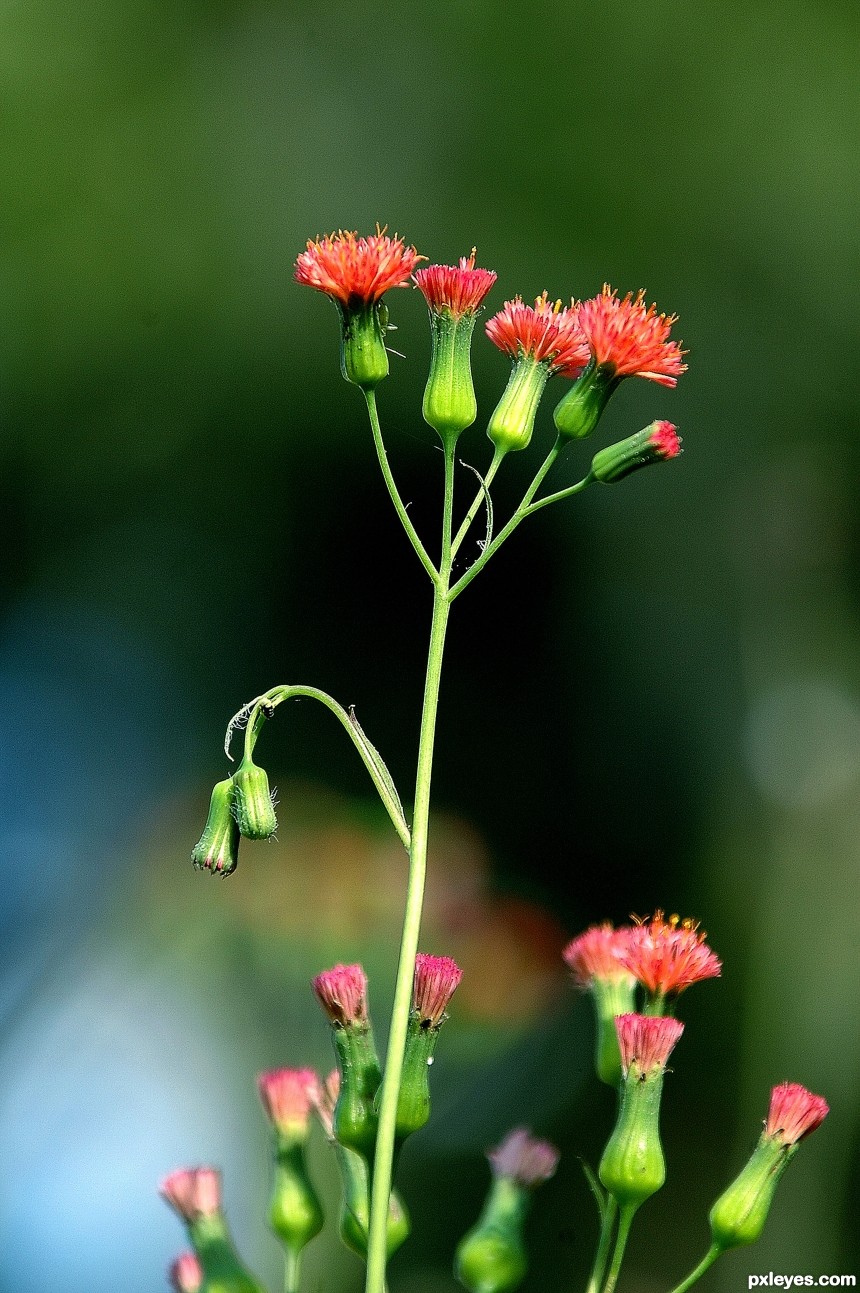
left=365, top=451, right=454, bottom=1293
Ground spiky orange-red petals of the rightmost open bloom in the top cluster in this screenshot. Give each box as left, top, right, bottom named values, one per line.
left=577, top=283, right=687, bottom=387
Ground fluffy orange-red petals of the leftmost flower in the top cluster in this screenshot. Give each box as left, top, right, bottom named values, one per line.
left=295, top=226, right=424, bottom=309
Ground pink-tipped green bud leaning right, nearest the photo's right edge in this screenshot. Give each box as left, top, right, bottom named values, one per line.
left=710, top=1082, right=829, bottom=1253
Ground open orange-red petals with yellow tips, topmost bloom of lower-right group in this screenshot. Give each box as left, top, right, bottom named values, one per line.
left=621, top=912, right=723, bottom=996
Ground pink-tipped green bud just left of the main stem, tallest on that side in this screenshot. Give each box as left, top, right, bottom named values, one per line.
left=313, top=965, right=382, bottom=1159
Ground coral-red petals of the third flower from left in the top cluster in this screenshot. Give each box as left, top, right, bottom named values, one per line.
left=486, top=292, right=591, bottom=378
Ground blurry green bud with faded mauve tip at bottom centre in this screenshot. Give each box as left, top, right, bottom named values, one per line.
left=454, top=1127, right=559, bottom=1293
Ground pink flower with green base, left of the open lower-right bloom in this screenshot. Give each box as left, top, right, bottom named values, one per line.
left=563, top=923, right=636, bottom=1087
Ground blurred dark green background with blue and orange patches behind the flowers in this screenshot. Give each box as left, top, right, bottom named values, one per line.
left=0, top=0, right=860, bottom=1293
